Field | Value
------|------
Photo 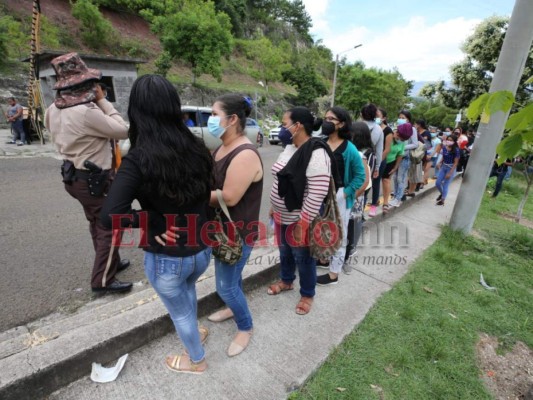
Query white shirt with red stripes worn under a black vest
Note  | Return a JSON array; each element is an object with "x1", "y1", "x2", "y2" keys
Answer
[{"x1": 270, "y1": 145, "x2": 331, "y2": 225}]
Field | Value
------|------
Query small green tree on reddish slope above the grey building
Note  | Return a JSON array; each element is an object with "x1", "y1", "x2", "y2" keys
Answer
[{"x1": 72, "y1": 0, "x2": 117, "y2": 50}]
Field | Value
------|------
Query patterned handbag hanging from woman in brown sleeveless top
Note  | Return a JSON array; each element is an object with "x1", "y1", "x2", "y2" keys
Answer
[{"x1": 212, "y1": 189, "x2": 243, "y2": 265}]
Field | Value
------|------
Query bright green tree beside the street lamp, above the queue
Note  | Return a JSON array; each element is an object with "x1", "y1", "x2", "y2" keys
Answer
[{"x1": 335, "y1": 62, "x2": 412, "y2": 114}]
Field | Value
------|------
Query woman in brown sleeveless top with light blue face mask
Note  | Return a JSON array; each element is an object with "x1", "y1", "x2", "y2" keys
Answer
[{"x1": 207, "y1": 94, "x2": 263, "y2": 357}]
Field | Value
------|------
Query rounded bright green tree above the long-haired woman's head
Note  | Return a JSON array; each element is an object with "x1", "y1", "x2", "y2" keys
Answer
[{"x1": 152, "y1": 1, "x2": 233, "y2": 82}]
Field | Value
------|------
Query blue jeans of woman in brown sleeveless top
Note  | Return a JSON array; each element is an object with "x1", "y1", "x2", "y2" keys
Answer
[{"x1": 215, "y1": 244, "x2": 253, "y2": 331}]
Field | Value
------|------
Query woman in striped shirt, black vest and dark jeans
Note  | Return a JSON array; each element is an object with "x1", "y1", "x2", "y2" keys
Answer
[{"x1": 267, "y1": 107, "x2": 339, "y2": 315}]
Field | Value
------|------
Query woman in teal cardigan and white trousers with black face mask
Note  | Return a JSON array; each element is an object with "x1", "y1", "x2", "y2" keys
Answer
[{"x1": 316, "y1": 107, "x2": 366, "y2": 286}]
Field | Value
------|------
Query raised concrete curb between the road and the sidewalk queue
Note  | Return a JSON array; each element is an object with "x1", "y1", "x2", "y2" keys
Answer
[{"x1": 0, "y1": 179, "x2": 446, "y2": 400}]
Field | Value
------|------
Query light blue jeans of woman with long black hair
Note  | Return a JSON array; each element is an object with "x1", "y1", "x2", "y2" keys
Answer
[{"x1": 144, "y1": 248, "x2": 211, "y2": 362}]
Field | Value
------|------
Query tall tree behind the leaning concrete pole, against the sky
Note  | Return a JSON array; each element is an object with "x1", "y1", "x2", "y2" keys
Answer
[{"x1": 439, "y1": 16, "x2": 533, "y2": 108}]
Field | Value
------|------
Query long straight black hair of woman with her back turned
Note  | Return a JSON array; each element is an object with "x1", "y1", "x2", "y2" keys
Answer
[{"x1": 128, "y1": 75, "x2": 214, "y2": 205}]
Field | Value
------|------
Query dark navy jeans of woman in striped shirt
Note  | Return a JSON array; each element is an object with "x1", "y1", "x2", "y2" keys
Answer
[{"x1": 279, "y1": 225, "x2": 316, "y2": 297}]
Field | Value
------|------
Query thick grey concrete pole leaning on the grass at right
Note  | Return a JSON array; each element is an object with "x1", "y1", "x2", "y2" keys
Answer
[{"x1": 450, "y1": 0, "x2": 533, "y2": 234}]
